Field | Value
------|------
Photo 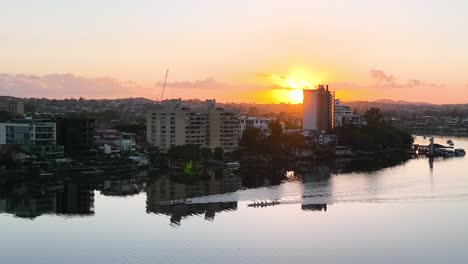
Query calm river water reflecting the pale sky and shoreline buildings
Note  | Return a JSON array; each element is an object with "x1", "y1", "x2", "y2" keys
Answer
[{"x1": 0, "y1": 138, "x2": 468, "y2": 263}]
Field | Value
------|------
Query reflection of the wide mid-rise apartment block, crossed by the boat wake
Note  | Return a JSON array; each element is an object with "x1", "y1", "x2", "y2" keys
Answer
[{"x1": 146, "y1": 170, "x2": 242, "y2": 226}]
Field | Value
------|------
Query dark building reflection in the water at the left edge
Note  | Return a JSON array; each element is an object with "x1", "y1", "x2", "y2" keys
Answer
[{"x1": 0, "y1": 180, "x2": 94, "y2": 218}]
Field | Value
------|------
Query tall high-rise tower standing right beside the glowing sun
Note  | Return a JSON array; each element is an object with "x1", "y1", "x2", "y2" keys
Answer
[{"x1": 303, "y1": 85, "x2": 335, "y2": 132}]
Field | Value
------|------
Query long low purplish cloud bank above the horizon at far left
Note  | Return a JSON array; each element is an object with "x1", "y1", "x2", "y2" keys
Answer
[{"x1": 0, "y1": 73, "x2": 148, "y2": 98}]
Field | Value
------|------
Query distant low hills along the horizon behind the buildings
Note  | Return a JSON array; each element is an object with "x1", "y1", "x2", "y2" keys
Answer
[{"x1": 6, "y1": 97, "x2": 468, "y2": 117}]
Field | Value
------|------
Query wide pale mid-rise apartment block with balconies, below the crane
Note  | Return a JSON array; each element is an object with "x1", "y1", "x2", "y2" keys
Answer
[{"x1": 146, "y1": 99, "x2": 239, "y2": 152}]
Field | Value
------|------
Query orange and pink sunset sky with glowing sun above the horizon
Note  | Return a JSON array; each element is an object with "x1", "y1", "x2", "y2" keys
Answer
[{"x1": 0, "y1": 0, "x2": 468, "y2": 103}]
